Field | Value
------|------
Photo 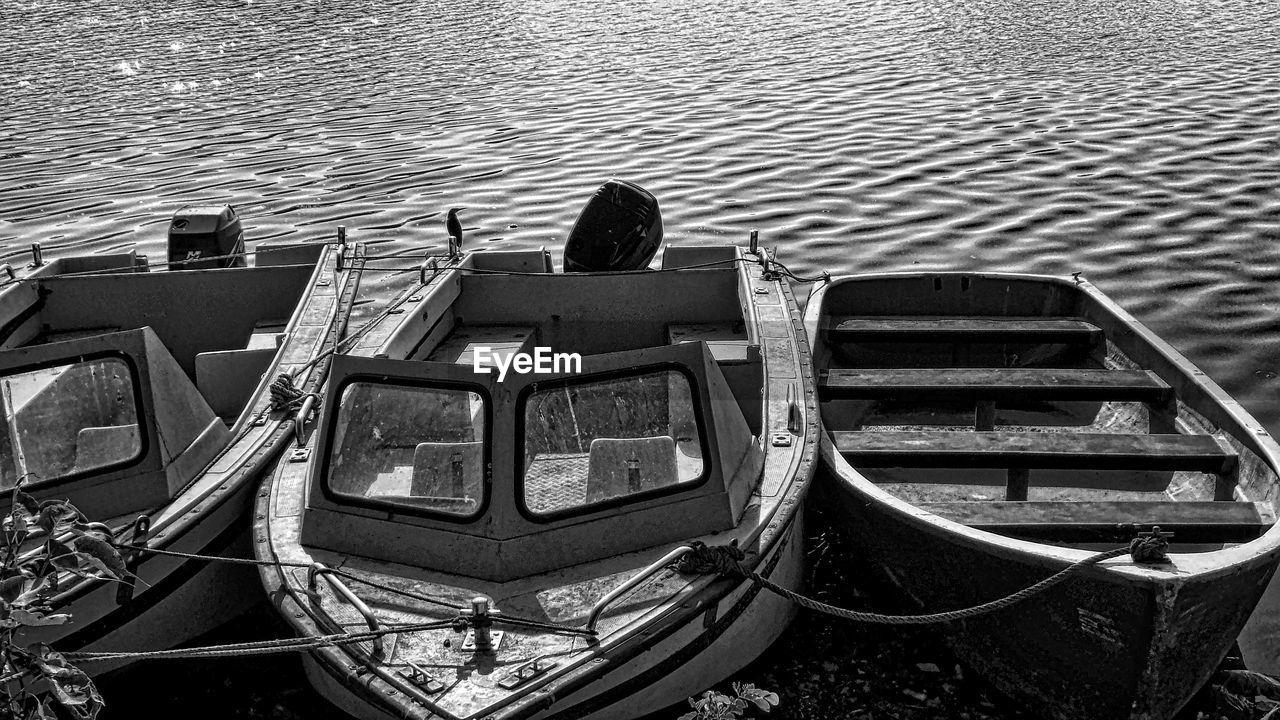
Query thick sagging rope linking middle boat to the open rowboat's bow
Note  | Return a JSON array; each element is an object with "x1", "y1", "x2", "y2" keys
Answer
[{"x1": 676, "y1": 533, "x2": 1169, "y2": 625}]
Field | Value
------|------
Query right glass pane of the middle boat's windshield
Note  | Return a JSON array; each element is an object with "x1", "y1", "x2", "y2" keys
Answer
[{"x1": 524, "y1": 370, "x2": 705, "y2": 514}]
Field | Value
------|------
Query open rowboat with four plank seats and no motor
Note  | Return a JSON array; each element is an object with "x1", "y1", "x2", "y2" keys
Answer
[{"x1": 805, "y1": 273, "x2": 1280, "y2": 720}]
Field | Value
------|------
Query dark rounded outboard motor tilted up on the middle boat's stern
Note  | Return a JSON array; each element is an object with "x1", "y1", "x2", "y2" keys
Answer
[{"x1": 564, "y1": 179, "x2": 662, "y2": 273}]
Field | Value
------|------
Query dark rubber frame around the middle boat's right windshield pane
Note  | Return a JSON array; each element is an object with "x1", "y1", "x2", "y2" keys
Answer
[{"x1": 512, "y1": 360, "x2": 716, "y2": 525}]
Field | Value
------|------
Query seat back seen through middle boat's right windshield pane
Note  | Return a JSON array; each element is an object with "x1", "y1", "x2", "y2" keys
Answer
[{"x1": 586, "y1": 436, "x2": 680, "y2": 502}]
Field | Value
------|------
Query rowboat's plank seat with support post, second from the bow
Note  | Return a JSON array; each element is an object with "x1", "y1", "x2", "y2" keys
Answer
[{"x1": 831, "y1": 430, "x2": 1239, "y2": 500}]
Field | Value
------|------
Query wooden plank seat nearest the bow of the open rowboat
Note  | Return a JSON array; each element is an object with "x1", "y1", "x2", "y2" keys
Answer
[{"x1": 916, "y1": 501, "x2": 1276, "y2": 543}]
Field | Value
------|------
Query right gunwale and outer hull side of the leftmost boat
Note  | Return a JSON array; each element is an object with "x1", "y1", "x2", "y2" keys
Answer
[{"x1": 8, "y1": 243, "x2": 356, "y2": 675}]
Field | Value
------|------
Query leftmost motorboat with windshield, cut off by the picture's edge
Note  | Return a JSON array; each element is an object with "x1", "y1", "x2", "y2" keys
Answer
[{"x1": 0, "y1": 209, "x2": 358, "y2": 674}]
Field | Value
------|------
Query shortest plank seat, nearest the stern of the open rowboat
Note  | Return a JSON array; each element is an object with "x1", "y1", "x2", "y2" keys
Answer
[{"x1": 827, "y1": 316, "x2": 1102, "y2": 345}]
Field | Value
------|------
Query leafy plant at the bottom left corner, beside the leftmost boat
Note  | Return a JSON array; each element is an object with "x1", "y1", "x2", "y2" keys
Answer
[{"x1": 0, "y1": 487, "x2": 128, "y2": 720}]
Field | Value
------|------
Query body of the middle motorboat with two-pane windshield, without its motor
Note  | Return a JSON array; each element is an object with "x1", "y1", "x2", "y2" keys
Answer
[{"x1": 255, "y1": 242, "x2": 818, "y2": 720}]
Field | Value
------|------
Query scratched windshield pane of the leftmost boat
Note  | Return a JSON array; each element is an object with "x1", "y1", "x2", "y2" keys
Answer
[{"x1": 0, "y1": 357, "x2": 142, "y2": 489}]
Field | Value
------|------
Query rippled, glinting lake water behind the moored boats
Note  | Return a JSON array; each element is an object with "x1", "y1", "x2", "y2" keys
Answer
[{"x1": 0, "y1": 0, "x2": 1280, "y2": 712}]
